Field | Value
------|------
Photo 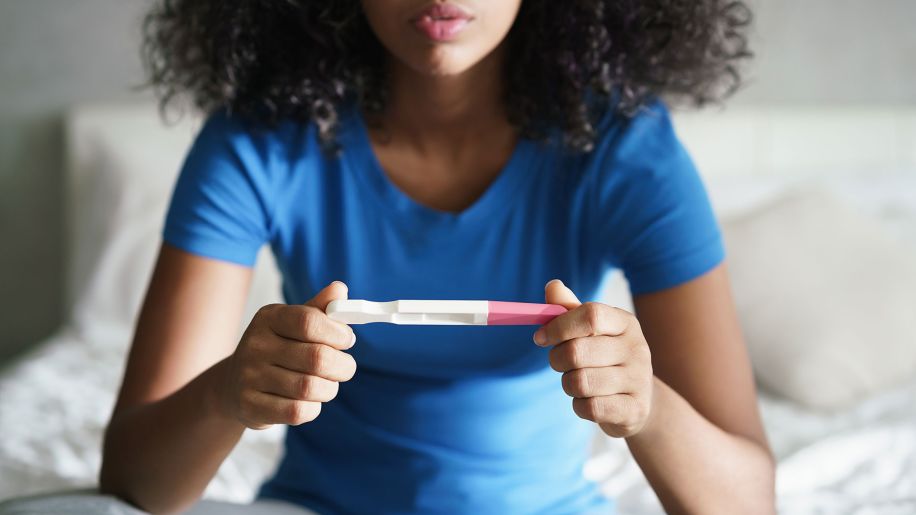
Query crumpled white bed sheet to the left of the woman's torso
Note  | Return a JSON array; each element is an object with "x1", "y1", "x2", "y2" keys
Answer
[{"x1": 0, "y1": 330, "x2": 283, "y2": 501}]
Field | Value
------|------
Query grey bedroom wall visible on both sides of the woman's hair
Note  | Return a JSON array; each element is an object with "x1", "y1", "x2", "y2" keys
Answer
[{"x1": 0, "y1": 0, "x2": 916, "y2": 362}]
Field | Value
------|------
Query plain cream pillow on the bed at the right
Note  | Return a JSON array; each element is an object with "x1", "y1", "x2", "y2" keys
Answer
[{"x1": 722, "y1": 188, "x2": 916, "y2": 409}]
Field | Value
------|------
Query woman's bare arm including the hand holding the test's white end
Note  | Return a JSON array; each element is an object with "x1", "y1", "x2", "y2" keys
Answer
[{"x1": 100, "y1": 244, "x2": 356, "y2": 513}]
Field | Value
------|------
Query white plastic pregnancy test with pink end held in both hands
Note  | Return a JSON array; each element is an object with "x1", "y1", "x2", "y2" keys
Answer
[{"x1": 325, "y1": 299, "x2": 566, "y2": 325}]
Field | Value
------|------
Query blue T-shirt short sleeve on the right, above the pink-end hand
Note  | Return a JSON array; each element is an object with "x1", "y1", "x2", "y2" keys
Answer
[{"x1": 590, "y1": 102, "x2": 725, "y2": 295}]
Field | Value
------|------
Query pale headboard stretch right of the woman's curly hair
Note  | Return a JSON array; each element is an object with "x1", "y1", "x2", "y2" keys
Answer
[{"x1": 675, "y1": 106, "x2": 916, "y2": 177}]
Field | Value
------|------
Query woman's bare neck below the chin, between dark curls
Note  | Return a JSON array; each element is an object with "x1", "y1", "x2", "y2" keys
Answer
[{"x1": 380, "y1": 46, "x2": 511, "y2": 153}]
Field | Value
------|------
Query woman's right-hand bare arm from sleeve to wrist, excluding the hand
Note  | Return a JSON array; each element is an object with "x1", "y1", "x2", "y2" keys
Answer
[{"x1": 627, "y1": 265, "x2": 775, "y2": 513}]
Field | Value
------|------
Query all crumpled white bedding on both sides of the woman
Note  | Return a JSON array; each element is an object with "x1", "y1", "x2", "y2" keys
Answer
[{"x1": 0, "y1": 330, "x2": 916, "y2": 514}]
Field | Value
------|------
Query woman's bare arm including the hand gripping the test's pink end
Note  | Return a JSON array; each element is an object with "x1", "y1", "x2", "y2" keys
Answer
[{"x1": 536, "y1": 265, "x2": 775, "y2": 514}]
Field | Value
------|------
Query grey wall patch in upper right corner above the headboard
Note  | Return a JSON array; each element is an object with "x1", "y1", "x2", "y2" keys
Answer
[{"x1": 735, "y1": 0, "x2": 916, "y2": 104}]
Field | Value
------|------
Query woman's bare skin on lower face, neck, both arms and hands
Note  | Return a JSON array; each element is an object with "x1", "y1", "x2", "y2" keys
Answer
[{"x1": 100, "y1": 0, "x2": 774, "y2": 513}]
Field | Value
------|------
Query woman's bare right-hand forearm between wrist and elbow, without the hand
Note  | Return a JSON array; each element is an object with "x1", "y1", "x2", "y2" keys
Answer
[{"x1": 627, "y1": 377, "x2": 775, "y2": 514}]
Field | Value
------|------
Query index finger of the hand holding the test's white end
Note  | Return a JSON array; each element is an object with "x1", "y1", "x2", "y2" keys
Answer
[{"x1": 270, "y1": 305, "x2": 356, "y2": 349}]
